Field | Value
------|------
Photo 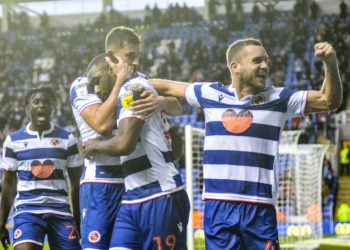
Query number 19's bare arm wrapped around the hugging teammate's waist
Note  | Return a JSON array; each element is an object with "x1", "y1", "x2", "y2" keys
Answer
[{"x1": 83, "y1": 117, "x2": 144, "y2": 156}]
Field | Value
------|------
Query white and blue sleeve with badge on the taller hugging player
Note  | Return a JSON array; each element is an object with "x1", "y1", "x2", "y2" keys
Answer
[{"x1": 70, "y1": 77, "x2": 102, "y2": 113}]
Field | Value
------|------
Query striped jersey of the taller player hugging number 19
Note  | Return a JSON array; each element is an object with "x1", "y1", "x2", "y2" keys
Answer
[{"x1": 70, "y1": 77, "x2": 124, "y2": 184}]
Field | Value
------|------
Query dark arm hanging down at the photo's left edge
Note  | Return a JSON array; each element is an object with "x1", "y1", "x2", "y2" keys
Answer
[{"x1": 0, "y1": 170, "x2": 17, "y2": 249}]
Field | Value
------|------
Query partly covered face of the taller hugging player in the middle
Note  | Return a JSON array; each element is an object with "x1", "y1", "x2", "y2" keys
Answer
[{"x1": 112, "y1": 42, "x2": 141, "y2": 71}]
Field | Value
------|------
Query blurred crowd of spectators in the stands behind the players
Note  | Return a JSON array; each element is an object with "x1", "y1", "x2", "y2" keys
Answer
[{"x1": 0, "y1": 0, "x2": 350, "y2": 148}]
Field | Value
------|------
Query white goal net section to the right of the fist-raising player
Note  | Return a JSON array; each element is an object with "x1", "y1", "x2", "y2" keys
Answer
[{"x1": 275, "y1": 144, "x2": 327, "y2": 249}]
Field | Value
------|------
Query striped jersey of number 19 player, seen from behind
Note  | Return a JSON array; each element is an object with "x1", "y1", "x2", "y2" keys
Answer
[{"x1": 118, "y1": 77, "x2": 183, "y2": 204}]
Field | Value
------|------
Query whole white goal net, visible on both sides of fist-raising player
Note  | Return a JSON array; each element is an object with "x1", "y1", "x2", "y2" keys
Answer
[{"x1": 185, "y1": 126, "x2": 327, "y2": 250}]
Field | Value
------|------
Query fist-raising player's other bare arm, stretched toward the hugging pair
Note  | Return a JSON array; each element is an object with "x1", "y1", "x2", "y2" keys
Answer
[{"x1": 149, "y1": 79, "x2": 190, "y2": 97}]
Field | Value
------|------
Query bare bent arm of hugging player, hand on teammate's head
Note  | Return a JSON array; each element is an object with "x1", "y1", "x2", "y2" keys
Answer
[{"x1": 81, "y1": 57, "x2": 133, "y2": 135}]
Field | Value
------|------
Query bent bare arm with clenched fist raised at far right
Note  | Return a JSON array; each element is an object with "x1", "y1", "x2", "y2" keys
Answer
[{"x1": 305, "y1": 42, "x2": 343, "y2": 113}]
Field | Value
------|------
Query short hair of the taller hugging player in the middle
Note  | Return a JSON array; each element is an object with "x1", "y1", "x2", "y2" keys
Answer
[{"x1": 105, "y1": 26, "x2": 141, "y2": 52}]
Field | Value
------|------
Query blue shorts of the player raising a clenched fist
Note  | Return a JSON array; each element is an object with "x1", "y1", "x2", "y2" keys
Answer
[{"x1": 203, "y1": 200, "x2": 280, "y2": 250}]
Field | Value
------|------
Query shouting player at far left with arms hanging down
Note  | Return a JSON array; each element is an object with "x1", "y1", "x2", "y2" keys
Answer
[{"x1": 0, "y1": 87, "x2": 83, "y2": 250}]
